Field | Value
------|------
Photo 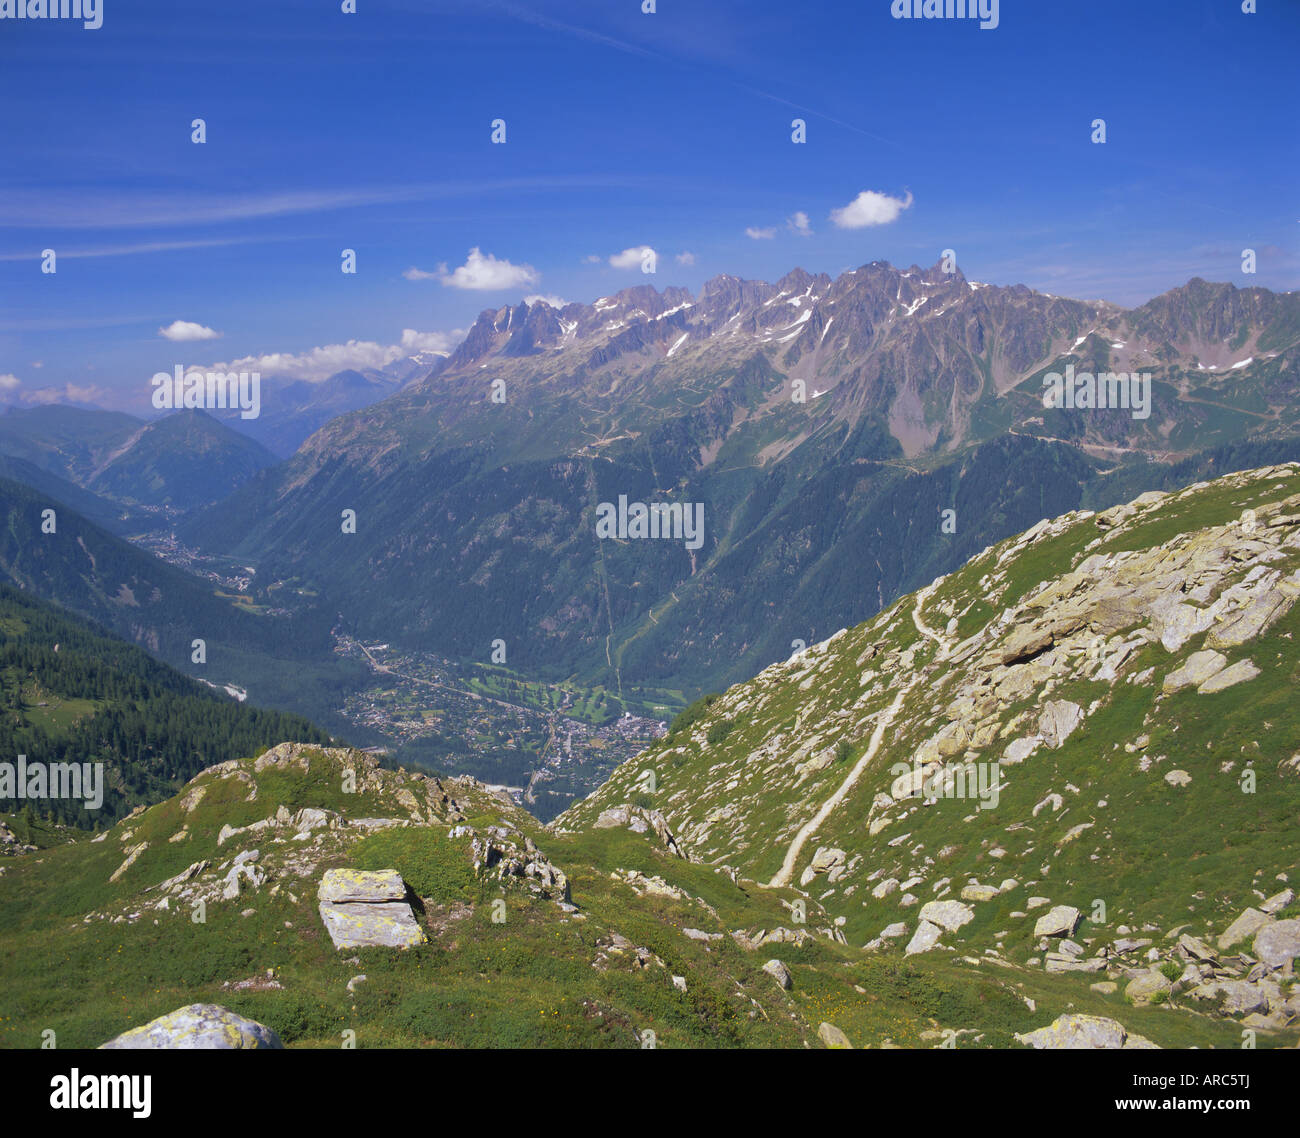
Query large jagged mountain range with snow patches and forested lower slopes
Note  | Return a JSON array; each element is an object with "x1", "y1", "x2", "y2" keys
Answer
[{"x1": 183, "y1": 263, "x2": 1300, "y2": 688}]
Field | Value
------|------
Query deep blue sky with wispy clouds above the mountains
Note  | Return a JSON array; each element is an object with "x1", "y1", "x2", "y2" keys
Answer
[{"x1": 0, "y1": 0, "x2": 1300, "y2": 412}]
